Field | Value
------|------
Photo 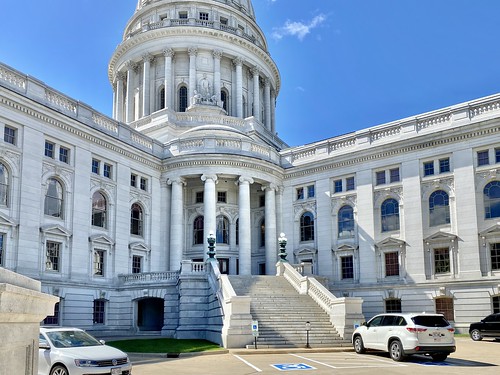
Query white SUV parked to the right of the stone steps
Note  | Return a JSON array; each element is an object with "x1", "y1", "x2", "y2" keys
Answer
[{"x1": 352, "y1": 313, "x2": 456, "y2": 361}]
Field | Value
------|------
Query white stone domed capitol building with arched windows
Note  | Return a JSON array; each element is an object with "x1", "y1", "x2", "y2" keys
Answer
[{"x1": 0, "y1": 0, "x2": 500, "y2": 347}]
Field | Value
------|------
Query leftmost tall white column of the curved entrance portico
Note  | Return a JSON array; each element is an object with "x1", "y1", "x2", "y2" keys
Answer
[{"x1": 168, "y1": 177, "x2": 186, "y2": 271}]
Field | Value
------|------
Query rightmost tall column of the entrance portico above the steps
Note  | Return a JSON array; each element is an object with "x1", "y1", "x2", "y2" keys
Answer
[{"x1": 262, "y1": 184, "x2": 278, "y2": 275}]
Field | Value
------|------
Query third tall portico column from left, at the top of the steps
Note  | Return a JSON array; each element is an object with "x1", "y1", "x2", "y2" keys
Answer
[{"x1": 238, "y1": 176, "x2": 253, "y2": 275}]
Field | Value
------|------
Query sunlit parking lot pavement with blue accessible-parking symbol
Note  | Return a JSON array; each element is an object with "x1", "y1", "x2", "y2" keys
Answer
[{"x1": 130, "y1": 337, "x2": 500, "y2": 375}]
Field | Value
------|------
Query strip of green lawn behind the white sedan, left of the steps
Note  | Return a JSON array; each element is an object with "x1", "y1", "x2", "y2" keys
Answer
[{"x1": 106, "y1": 338, "x2": 223, "y2": 353}]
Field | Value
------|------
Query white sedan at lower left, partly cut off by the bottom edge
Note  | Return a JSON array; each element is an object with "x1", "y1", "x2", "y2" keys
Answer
[{"x1": 38, "y1": 327, "x2": 132, "y2": 375}]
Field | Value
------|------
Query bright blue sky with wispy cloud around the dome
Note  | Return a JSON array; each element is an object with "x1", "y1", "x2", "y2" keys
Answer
[{"x1": 0, "y1": 0, "x2": 500, "y2": 146}]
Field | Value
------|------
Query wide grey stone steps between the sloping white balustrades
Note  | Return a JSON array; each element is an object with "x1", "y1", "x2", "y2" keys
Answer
[{"x1": 229, "y1": 276, "x2": 351, "y2": 348}]
